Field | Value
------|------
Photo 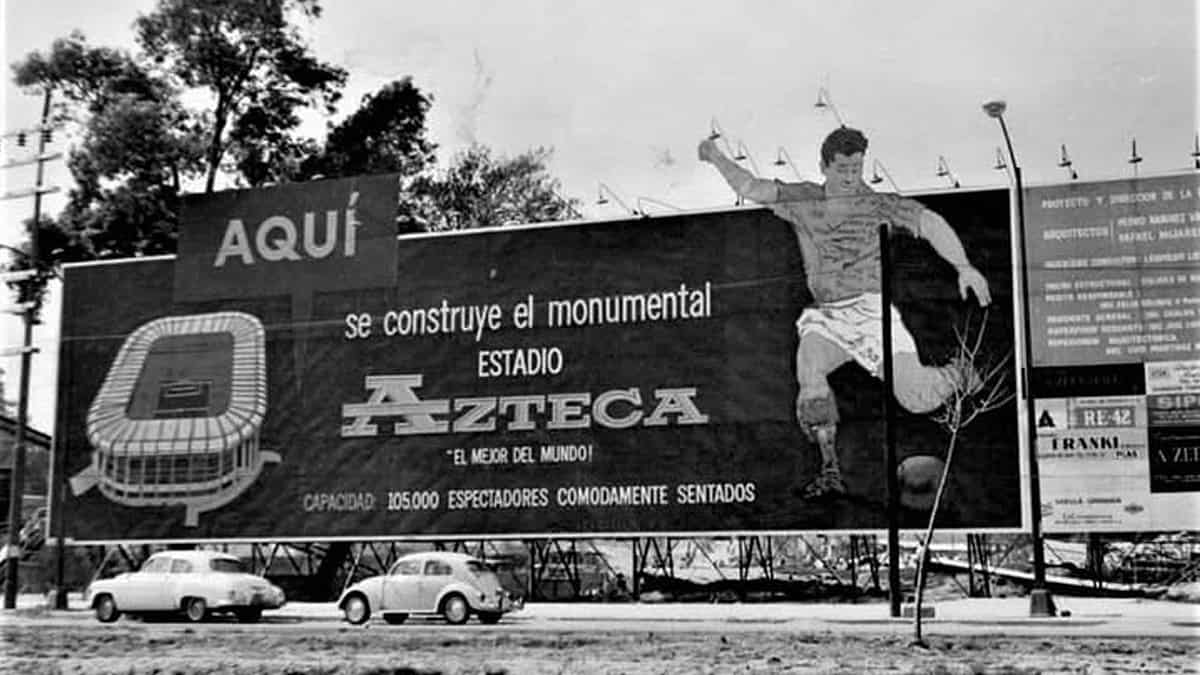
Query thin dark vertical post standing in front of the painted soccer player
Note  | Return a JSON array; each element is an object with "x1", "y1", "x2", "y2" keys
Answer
[{"x1": 880, "y1": 223, "x2": 900, "y2": 619}]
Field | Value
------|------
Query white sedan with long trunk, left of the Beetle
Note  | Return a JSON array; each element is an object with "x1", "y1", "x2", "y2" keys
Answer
[{"x1": 88, "y1": 550, "x2": 286, "y2": 623}]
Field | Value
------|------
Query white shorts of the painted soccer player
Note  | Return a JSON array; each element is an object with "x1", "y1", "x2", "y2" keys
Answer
[{"x1": 796, "y1": 293, "x2": 917, "y2": 378}]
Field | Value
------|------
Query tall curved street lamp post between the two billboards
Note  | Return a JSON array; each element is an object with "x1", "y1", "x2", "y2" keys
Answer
[{"x1": 983, "y1": 101, "x2": 1057, "y2": 616}]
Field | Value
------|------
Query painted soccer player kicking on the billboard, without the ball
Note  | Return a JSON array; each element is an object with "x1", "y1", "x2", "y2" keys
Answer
[{"x1": 700, "y1": 126, "x2": 991, "y2": 498}]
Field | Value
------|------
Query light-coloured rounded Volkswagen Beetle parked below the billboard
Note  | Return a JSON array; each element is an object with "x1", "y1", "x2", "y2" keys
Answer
[{"x1": 337, "y1": 551, "x2": 520, "y2": 623}]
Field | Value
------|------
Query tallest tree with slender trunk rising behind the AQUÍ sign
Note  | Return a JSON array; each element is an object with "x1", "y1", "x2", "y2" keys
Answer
[{"x1": 134, "y1": 0, "x2": 346, "y2": 192}]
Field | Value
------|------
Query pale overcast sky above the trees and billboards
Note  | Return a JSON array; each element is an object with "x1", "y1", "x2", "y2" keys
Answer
[{"x1": 0, "y1": 0, "x2": 1200, "y2": 431}]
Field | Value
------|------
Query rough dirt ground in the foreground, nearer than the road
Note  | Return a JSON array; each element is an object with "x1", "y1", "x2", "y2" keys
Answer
[{"x1": 0, "y1": 621, "x2": 1200, "y2": 675}]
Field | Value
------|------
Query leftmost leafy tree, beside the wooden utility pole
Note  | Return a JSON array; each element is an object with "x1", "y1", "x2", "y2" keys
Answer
[{"x1": 10, "y1": 31, "x2": 200, "y2": 300}]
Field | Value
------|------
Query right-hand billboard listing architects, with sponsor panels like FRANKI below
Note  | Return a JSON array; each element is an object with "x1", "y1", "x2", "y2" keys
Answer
[{"x1": 1026, "y1": 174, "x2": 1200, "y2": 532}]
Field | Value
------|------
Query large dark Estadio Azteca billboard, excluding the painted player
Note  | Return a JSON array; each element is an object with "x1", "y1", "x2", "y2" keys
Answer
[{"x1": 51, "y1": 180, "x2": 1021, "y2": 542}]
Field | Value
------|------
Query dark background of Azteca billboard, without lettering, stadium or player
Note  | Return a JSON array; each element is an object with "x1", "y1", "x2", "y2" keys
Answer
[{"x1": 56, "y1": 190, "x2": 1021, "y2": 540}]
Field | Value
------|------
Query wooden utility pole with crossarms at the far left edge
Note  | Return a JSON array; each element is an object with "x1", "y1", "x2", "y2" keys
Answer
[{"x1": 4, "y1": 89, "x2": 50, "y2": 609}]
